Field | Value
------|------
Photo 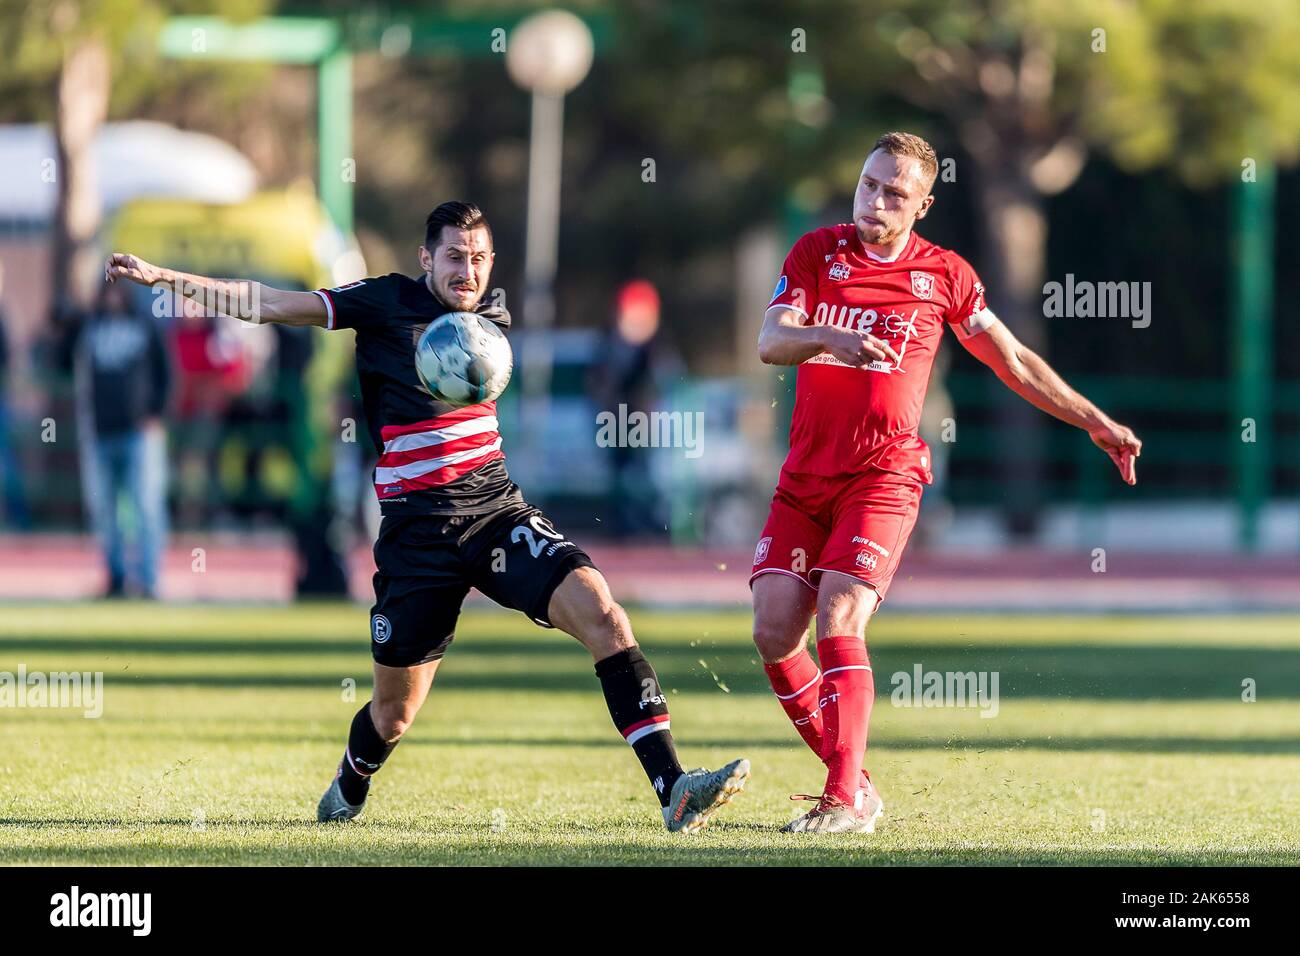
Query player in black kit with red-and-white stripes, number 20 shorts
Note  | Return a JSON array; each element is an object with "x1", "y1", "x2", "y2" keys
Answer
[{"x1": 104, "y1": 202, "x2": 749, "y2": 832}]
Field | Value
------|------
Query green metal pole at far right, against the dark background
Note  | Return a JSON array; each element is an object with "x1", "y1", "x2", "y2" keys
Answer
[{"x1": 1231, "y1": 160, "x2": 1275, "y2": 551}]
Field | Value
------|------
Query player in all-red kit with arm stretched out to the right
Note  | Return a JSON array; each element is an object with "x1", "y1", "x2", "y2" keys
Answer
[{"x1": 750, "y1": 133, "x2": 1141, "y2": 832}]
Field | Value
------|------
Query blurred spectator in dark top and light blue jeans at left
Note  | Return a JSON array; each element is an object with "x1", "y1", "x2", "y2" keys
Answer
[{"x1": 75, "y1": 284, "x2": 172, "y2": 598}]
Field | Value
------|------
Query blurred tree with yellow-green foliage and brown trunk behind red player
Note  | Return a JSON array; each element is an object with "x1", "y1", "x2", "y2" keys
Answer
[{"x1": 865, "y1": 0, "x2": 1300, "y2": 532}]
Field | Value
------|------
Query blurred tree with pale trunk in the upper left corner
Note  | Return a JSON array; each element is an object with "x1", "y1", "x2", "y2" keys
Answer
[{"x1": 0, "y1": 0, "x2": 267, "y2": 317}]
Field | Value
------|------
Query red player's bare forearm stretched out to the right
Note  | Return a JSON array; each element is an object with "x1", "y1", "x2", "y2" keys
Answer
[{"x1": 961, "y1": 319, "x2": 1141, "y2": 485}]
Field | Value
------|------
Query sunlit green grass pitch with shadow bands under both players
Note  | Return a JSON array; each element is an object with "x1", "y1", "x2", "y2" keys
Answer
[{"x1": 0, "y1": 604, "x2": 1300, "y2": 865}]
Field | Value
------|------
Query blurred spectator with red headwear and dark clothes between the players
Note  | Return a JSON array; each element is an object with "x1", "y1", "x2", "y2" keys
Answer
[{"x1": 592, "y1": 280, "x2": 681, "y2": 537}]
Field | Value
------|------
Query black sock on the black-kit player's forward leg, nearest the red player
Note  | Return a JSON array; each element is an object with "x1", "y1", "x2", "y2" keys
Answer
[{"x1": 595, "y1": 648, "x2": 681, "y2": 806}]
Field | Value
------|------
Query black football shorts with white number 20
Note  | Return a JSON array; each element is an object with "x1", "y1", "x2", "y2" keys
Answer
[{"x1": 371, "y1": 501, "x2": 594, "y2": 667}]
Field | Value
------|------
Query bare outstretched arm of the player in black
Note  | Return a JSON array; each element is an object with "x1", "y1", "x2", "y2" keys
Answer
[{"x1": 104, "y1": 252, "x2": 326, "y2": 326}]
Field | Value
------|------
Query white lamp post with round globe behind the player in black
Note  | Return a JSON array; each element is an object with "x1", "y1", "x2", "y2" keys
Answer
[{"x1": 506, "y1": 10, "x2": 594, "y2": 451}]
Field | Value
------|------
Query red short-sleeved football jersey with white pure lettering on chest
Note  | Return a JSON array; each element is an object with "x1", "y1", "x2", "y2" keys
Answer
[{"x1": 771, "y1": 222, "x2": 992, "y2": 484}]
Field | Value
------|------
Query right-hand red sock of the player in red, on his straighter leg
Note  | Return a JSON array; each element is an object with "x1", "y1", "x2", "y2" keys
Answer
[{"x1": 816, "y1": 637, "x2": 876, "y2": 804}]
